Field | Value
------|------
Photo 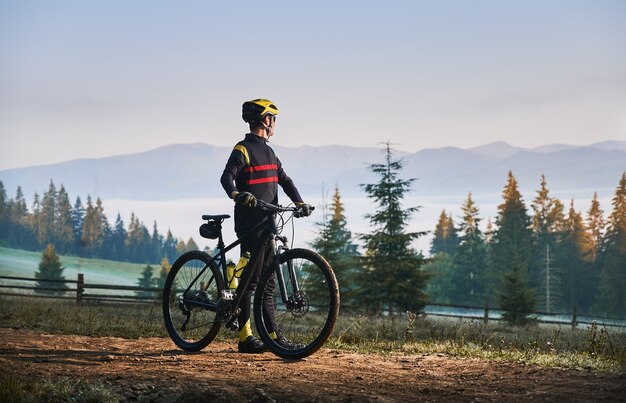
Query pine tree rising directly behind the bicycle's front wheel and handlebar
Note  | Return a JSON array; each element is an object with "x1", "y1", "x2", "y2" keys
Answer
[{"x1": 311, "y1": 187, "x2": 359, "y2": 306}]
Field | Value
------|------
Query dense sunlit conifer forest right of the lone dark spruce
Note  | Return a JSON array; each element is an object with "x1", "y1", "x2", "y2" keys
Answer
[{"x1": 426, "y1": 172, "x2": 626, "y2": 321}]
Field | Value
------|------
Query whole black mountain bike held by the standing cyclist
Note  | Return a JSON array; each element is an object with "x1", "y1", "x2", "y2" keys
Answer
[{"x1": 163, "y1": 200, "x2": 339, "y2": 359}]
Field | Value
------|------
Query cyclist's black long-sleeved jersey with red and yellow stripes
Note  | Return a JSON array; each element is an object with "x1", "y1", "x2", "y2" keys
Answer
[{"x1": 220, "y1": 133, "x2": 302, "y2": 233}]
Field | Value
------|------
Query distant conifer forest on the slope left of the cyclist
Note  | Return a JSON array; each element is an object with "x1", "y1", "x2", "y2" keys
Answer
[{"x1": 0, "y1": 181, "x2": 198, "y2": 264}]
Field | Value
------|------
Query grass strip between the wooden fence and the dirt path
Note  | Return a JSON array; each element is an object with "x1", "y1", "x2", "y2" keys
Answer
[{"x1": 0, "y1": 297, "x2": 626, "y2": 373}]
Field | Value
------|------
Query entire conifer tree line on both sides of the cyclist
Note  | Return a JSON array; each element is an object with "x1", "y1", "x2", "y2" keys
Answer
[{"x1": 0, "y1": 147, "x2": 626, "y2": 323}]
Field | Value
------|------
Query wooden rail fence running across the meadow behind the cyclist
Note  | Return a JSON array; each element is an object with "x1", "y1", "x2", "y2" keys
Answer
[{"x1": 0, "y1": 273, "x2": 626, "y2": 328}]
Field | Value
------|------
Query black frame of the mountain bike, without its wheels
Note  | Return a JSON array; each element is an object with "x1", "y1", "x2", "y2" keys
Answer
[{"x1": 183, "y1": 213, "x2": 299, "y2": 320}]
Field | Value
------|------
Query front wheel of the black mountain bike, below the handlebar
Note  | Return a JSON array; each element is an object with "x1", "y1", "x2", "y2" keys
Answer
[{"x1": 254, "y1": 249, "x2": 339, "y2": 359}]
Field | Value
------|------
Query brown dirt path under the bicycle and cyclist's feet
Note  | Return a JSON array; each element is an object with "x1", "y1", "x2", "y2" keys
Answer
[{"x1": 0, "y1": 329, "x2": 626, "y2": 402}]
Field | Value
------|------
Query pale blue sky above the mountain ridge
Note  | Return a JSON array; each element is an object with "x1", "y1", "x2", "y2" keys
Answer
[{"x1": 0, "y1": 0, "x2": 626, "y2": 169}]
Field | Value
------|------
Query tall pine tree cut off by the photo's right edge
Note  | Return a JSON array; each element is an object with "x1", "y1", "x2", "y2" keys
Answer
[{"x1": 596, "y1": 173, "x2": 626, "y2": 316}]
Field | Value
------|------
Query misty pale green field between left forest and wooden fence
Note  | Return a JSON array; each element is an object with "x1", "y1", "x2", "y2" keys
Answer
[{"x1": 0, "y1": 247, "x2": 159, "y2": 285}]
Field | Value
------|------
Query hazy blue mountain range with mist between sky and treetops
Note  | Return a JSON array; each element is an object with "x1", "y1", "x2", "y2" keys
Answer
[{"x1": 0, "y1": 141, "x2": 626, "y2": 200}]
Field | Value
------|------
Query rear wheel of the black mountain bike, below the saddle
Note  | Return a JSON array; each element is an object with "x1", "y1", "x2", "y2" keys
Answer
[{"x1": 163, "y1": 251, "x2": 224, "y2": 351}]
